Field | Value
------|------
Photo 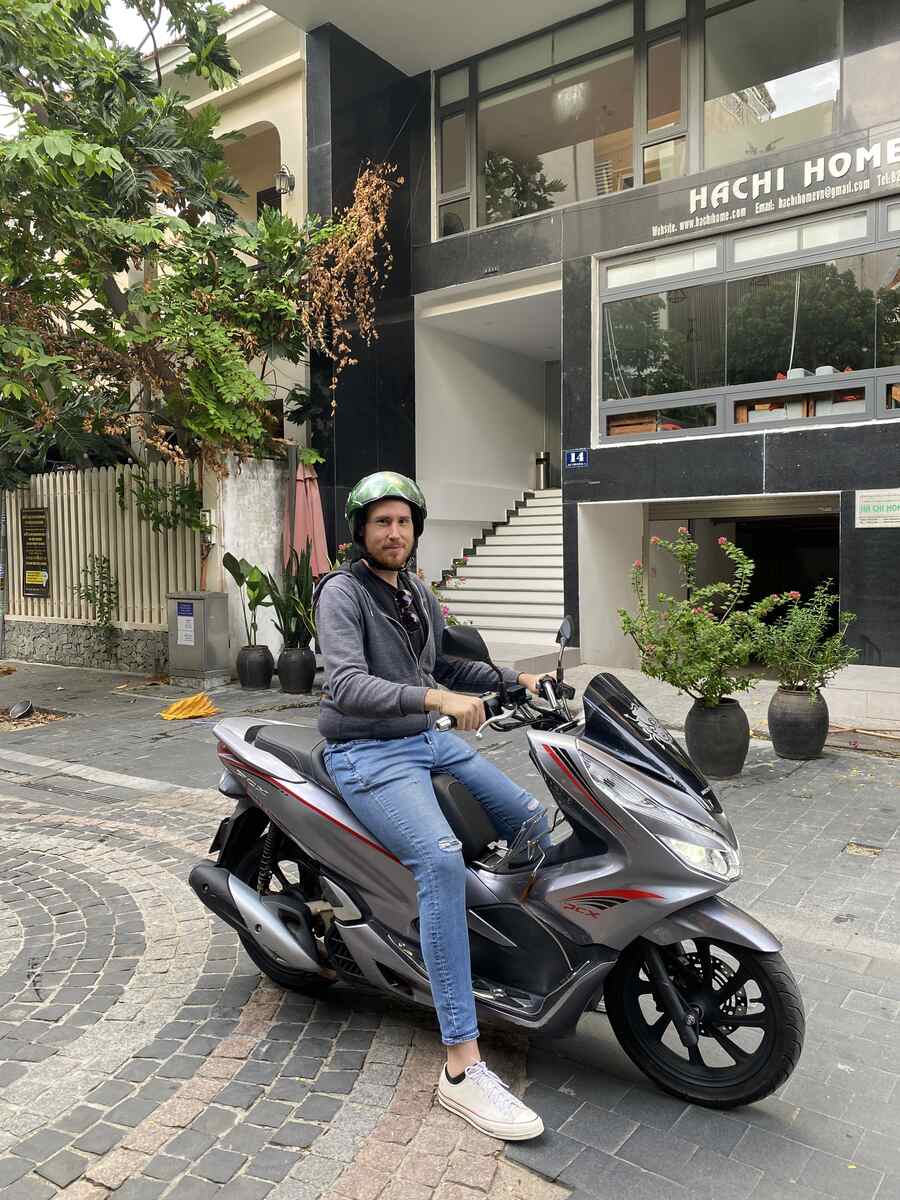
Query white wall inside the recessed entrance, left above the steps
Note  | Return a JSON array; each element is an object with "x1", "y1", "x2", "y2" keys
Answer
[{"x1": 415, "y1": 317, "x2": 545, "y2": 580}]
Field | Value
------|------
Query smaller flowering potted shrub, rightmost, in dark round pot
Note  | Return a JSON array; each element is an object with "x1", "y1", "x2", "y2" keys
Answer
[{"x1": 755, "y1": 580, "x2": 857, "y2": 760}]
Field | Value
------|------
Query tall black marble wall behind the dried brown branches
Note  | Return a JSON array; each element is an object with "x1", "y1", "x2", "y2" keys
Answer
[{"x1": 307, "y1": 25, "x2": 430, "y2": 551}]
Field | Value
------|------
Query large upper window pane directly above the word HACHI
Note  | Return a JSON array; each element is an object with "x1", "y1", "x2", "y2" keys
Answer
[{"x1": 703, "y1": 0, "x2": 844, "y2": 167}]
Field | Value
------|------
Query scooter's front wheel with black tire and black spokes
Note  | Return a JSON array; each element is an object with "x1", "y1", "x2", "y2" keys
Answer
[{"x1": 605, "y1": 938, "x2": 806, "y2": 1109}]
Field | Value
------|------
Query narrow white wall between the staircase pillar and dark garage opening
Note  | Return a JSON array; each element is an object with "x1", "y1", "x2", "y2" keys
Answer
[{"x1": 578, "y1": 503, "x2": 646, "y2": 667}]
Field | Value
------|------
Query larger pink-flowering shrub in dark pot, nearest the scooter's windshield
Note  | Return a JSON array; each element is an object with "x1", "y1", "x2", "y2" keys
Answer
[{"x1": 619, "y1": 527, "x2": 779, "y2": 779}]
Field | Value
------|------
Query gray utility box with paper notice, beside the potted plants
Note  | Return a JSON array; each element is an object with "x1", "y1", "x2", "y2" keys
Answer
[{"x1": 166, "y1": 592, "x2": 232, "y2": 688}]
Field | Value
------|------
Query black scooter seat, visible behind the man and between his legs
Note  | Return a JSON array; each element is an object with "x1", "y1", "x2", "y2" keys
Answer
[{"x1": 253, "y1": 725, "x2": 498, "y2": 863}]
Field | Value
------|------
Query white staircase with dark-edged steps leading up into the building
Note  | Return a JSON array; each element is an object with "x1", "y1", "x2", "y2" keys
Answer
[{"x1": 440, "y1": 488, "x2": 563, "y2": 671}]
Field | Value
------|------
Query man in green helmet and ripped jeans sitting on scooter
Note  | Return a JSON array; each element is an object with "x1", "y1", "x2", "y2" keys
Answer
[{"x1": 314, "y1": 472, "x2": 554, "y2": 1140}]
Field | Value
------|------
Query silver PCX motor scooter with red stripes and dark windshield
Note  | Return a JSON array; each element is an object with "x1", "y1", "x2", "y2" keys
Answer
[{"x1": 190, "y1": 618, "x2": 804, "y2": 1109}]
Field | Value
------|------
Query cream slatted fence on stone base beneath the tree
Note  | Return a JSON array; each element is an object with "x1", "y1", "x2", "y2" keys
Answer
[{"x1": 6, "y1": 463, "x2": 200, "y2": 629}]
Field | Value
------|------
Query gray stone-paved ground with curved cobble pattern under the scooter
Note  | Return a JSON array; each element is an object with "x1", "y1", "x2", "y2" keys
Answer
[{"x1": 0, "y1": 662, "x2": 900, "y2": 1200}]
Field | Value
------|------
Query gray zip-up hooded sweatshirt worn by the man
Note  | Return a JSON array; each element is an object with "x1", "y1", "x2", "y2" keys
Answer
[{"x1": 313, "y1": 564, "x2": 516, "y2": 742}]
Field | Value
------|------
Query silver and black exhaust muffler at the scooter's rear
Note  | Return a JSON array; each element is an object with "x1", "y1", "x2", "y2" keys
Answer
[{"x1": 187, "y1": 863, "x2": 323, "y2": 974}]
